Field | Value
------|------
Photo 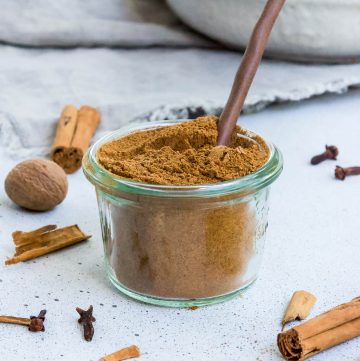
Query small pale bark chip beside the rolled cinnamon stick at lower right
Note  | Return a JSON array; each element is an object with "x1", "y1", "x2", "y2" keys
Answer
[{"x1": 282, "y1": 291, "x2": 316, "y2": 327}]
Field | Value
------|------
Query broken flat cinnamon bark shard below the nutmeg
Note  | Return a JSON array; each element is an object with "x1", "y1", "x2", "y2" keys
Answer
[{"x1": 5, "y1": 225, "x2": 91, "y2": 265}]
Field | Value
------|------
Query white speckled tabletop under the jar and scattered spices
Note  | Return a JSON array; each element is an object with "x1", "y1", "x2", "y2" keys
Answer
[{"x1": 0, "y1": 90, "x2": 360, "y2": 361}]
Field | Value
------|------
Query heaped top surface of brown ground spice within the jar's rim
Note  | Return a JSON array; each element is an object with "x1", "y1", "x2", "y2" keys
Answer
[{"x1": 97, "y1": 116, "x2": 269, "y2": 185}]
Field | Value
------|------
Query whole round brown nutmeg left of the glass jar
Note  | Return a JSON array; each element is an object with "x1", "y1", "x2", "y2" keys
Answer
[{"x1": 5, "y1": 159, "x2": 68, "y2": 211}]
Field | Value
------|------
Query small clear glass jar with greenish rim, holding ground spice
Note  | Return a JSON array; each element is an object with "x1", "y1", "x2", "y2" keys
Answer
[{"x1": 83, "y1": 122, "x2": 283, "y2": 307}]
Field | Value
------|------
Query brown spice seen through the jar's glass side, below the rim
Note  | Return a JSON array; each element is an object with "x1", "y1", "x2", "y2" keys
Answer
[{"x1": 107, "y1": 196, "x2": 260, "y2": 299}]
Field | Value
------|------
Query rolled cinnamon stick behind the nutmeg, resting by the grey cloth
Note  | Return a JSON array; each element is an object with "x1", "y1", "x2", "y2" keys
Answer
[{"x1": 50, "y1": 105, "x2": 100, "y2": 173}]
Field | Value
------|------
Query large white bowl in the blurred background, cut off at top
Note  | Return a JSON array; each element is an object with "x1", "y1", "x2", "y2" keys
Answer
[{"x1": 167, "y1": 0, "x2": 360, "y2": 62}]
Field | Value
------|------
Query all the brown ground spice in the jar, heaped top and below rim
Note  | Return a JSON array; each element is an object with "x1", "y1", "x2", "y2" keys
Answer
[{"x1": 97, "y1": 117, "x2": 269, "y2": 299}]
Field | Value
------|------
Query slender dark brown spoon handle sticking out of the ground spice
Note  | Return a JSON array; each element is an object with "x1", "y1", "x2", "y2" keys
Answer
[{"x1": 218, "y1": 0, "x2": 285, "y2": 145}]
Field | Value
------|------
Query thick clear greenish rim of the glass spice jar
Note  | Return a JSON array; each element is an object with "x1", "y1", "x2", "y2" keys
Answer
[{"x1": 82, "y1": 120, "x2": 283, "y2": 197}]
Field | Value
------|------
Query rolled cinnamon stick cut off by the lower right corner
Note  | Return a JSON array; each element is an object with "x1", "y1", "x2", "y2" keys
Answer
[{"x1": 277, "y1": 297, "x2": 360, "y2": 361}]
